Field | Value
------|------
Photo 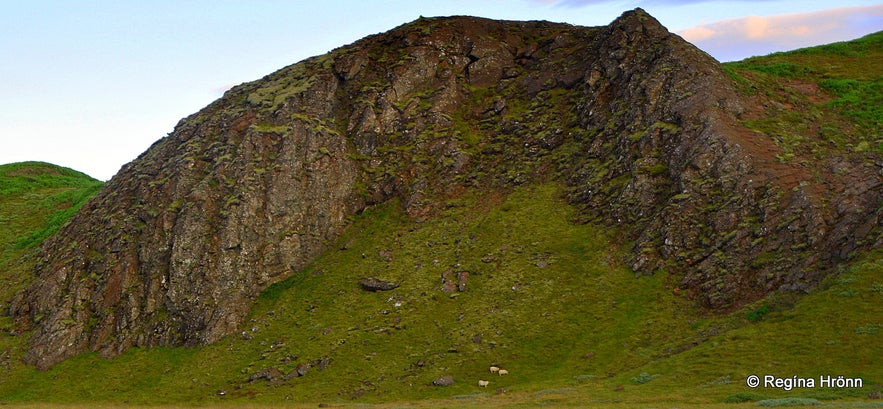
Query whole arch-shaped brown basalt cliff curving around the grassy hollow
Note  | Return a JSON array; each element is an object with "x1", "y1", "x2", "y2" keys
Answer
[{"x1": 12, "y1": 9, "x2": 880, "y2": 368}]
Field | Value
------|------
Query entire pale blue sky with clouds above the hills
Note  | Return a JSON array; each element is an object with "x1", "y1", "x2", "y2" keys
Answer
[{"x1": 0, "y1": 0, "x2": 883, "y2": 180}]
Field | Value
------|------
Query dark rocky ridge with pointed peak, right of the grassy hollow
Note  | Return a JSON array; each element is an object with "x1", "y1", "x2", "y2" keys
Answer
[{"x1": 565, "y1": 11, "x2": 883, "y2": 310}]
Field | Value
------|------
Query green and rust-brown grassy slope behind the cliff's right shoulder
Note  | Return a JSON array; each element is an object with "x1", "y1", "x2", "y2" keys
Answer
[{"x1": 724, "y1": 32, "x2": 883, "y2": 156}]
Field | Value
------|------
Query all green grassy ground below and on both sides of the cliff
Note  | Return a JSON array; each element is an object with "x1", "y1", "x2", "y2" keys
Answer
[{"x1": 0, "y1": 33, "x2": 883, "y2": 408}]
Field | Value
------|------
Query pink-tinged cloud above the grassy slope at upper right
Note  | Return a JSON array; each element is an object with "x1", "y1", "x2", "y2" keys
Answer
[{"x1": 678, "y1": 4, "x2": 883, "y2": 61}]
